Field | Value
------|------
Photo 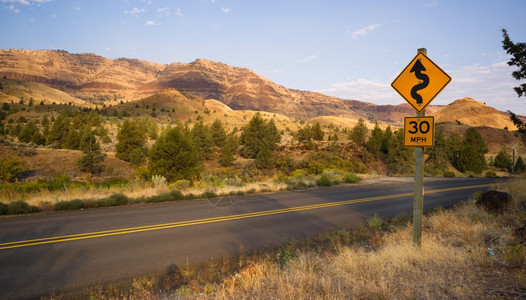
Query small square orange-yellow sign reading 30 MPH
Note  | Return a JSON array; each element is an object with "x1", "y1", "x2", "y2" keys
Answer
[{"x1": 404, "y1": 117, "x2": 435, "y2": 147}]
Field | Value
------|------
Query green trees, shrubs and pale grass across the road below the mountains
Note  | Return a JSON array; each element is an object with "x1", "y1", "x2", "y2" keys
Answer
[{"x1": 0, "y1": 96, "x2": 526, "y2": 214}]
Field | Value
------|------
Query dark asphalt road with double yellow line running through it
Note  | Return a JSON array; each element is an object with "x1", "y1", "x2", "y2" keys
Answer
[{"x1": 0, "y1": 178, "x2": 504, "y2": 299}]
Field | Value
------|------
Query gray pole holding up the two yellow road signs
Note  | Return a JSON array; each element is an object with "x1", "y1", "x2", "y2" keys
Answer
[{"x1": 413, "y1": 48, "x2": 427, "y2": 247}]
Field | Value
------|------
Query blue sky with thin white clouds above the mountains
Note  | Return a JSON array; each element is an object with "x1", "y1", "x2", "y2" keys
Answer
[{"x1": 0, "y1": 0, "x2": 526, "y2": 115}]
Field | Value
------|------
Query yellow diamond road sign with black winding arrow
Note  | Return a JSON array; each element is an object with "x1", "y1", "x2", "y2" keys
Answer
[{"x1": 391, "y1": 52, "x2": 451, "y2": 112}]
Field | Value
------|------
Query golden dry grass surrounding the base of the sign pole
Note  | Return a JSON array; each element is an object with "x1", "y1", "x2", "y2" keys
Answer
[{"x1": 201, "y1": 179, "x2": 526, "y2": 299}]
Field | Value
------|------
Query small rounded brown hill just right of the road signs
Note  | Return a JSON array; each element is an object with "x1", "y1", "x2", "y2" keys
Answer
[{"x1": 432, "y1": 98, "x2": 517, "y2": 130}]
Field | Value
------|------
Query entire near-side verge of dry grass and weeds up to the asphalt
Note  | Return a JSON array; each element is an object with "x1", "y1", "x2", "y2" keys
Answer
[{"x1": 50, "y1": 177, "x2": 526, "y2": 299}]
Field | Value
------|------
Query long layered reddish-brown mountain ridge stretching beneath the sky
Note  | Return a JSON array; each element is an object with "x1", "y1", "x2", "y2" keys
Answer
[{"x1": 0, "y1": 50, "x2": 512, "y2": 128}]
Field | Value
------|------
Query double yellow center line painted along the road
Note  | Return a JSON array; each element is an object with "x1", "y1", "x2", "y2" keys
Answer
[{"x1": 0, "y1": 184, "x2": 490, "y2": 250}]
